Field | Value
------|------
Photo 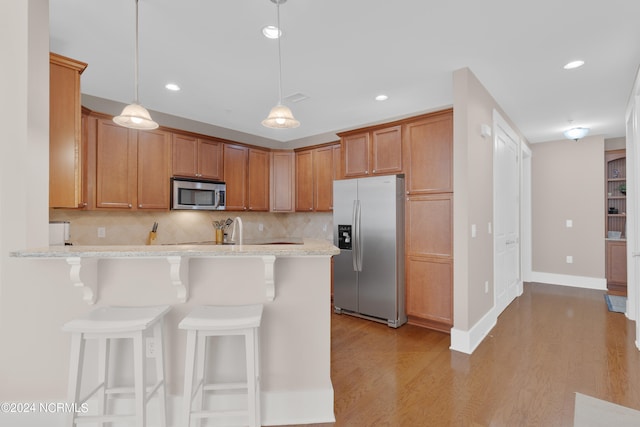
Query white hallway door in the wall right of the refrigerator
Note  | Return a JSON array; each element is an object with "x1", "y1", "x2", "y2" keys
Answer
[{"x1": 493, "y1": 111, "x2": 521, "y2": 315}]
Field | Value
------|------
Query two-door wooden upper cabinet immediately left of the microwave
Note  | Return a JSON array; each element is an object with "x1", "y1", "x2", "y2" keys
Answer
[{"x1": 89, "y1": 118, "x2": 171, "y2": 210}]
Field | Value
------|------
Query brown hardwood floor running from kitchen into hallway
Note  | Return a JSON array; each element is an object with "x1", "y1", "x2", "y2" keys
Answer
[{"x1": 282, "y1": 283, "x2": 640, "y2": 427}]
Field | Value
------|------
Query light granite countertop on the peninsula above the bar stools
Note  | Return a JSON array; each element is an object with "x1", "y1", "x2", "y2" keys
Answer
[{"x1": 10, "y1": 239, "x2": 340, "y2": 258}]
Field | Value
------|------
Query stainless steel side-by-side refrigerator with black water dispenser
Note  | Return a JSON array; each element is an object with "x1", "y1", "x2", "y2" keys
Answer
[{"x1": 333, "y1": 175, "x2": 407, "y2": 328}]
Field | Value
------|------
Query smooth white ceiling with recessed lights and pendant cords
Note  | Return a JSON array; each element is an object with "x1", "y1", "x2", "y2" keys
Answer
[{"x1": 49, "y1": 0, "x2": 640, "y2": 146}]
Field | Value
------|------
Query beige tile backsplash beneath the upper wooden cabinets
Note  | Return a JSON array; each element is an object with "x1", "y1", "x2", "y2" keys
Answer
[{"x1": 49, "y1": 209, "x2": 333, "y2": 245}]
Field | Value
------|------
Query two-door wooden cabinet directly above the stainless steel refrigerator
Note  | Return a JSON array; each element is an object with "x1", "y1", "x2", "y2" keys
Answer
[{"x1": 339, "y1": 125, "x2": 402, "y2": 178}]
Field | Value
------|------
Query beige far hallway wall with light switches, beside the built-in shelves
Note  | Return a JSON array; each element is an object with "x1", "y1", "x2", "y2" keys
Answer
[{"x1": 531, "y1": 136, "x2": 606, "y2": 289}]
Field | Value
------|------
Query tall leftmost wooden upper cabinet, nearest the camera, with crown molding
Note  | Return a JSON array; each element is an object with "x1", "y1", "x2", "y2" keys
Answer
[{"x1": 49, "y1": 53, "x2": 87, "y2": 208}]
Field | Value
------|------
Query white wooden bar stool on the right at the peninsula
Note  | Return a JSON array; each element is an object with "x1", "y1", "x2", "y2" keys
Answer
[{"x1": 179, "y1": 304, "x2": 262, "y2": 427}]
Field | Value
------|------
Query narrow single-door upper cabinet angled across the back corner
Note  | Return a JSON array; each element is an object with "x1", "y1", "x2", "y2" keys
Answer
[{"x1": 270, "y1": 151, "x2": 295, "y2": 212}]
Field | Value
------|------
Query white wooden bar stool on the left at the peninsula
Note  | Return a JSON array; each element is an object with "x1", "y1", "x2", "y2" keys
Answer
[{"x1": 62, "y1": 305, "x2": 170, "y2": 427}]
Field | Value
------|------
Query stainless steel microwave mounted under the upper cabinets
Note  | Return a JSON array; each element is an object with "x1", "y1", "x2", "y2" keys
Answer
[{"x1": 171, "y1": 178, "x2": 227, "y2": 211}]
